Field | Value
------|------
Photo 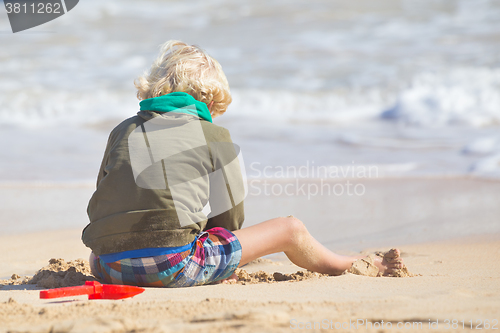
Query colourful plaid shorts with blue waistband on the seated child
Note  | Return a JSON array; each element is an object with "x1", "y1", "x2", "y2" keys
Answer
[{"x1": 94, "y1": 227, "x2": 241, "y2": 288}]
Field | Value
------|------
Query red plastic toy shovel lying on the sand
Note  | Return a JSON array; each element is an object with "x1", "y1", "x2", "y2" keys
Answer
[{"x1": 40, "y1": 281, "x2": 145, "y2": 299}]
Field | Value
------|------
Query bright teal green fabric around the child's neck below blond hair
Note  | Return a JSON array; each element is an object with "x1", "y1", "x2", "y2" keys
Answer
[{"x1": 139, "y1": 92, "x2": 212, "y2": 122}]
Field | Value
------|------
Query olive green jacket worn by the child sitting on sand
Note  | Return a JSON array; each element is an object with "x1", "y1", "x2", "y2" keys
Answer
[{"x1": 82, "y1": 111, "x2": 244, "y2": 255}]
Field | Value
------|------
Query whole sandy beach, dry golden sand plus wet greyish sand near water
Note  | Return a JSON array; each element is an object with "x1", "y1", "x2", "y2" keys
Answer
[{"x1": 0, "y1": 177, "x2": 500, "y2": 332}]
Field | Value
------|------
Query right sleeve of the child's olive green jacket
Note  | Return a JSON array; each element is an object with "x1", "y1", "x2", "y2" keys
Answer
[{"x1": 205, "y1": 129, "x2": 246, "y2": 231}]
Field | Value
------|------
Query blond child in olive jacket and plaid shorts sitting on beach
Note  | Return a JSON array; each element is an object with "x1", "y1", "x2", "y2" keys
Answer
[{"x1": 82, "y1": 41, "x2": 403, "y2": 287}]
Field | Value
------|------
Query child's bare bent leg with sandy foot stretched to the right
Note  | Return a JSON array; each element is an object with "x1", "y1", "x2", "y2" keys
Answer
[{"x1": 233, "y1": 216, "x2": 403, "y2": 275}]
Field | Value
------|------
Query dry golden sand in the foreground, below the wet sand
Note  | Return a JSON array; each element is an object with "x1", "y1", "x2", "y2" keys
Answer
[{"x1": 0, "y1": 230, "x2": 500, "y2": 332}]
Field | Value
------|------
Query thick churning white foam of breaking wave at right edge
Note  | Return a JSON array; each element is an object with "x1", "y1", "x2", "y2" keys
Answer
[{"x1": 382, "y1": 68, "x2": 500, "y2": 127}]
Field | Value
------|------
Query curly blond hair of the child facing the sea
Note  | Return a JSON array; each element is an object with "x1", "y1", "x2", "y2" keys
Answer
[{"x1": 134, "y1": 40, "x2": 232, "y2": 117}]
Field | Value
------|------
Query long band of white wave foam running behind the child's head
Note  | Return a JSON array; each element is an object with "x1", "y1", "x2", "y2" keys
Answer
[{"x1": 0, "y1": 67, "x2": 500, "y2": 128}]
